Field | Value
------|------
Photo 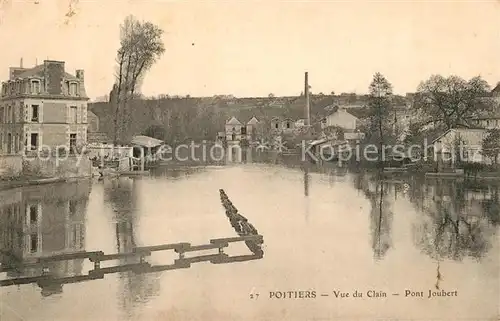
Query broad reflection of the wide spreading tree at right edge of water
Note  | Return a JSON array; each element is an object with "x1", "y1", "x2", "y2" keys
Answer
[{"x1": 410, "y1": 180, "x2": 499, "y2": 260}]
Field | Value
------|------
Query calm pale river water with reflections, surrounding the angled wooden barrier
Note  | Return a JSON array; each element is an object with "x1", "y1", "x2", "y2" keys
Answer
[{"x1": 0, "y1": 165, "x2": 500, "y2": 321}]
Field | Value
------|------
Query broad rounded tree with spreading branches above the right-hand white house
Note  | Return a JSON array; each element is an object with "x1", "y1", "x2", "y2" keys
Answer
[{"x1": 415, "y1": 75, "x2": 493, "y2": 130}]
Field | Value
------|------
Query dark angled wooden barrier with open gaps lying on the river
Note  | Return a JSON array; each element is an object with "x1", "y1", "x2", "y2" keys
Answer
[{"x1": 0, "y1": 190, "x2": 264, "y2": 292}]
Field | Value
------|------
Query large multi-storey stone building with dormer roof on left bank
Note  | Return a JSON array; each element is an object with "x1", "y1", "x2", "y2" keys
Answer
[{"x1": 0, "y1": 60, "x2": 88, "y2": 154}]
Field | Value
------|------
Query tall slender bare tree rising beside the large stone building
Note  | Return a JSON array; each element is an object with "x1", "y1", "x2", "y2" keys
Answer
[{"x1": 113, "y1": 15, "x2": 165, "y2": 144}]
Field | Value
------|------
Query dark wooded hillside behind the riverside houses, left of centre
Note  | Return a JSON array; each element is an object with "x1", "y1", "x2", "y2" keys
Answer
[{"x1": 89, "y1": 95, "x2": 335, "y2": 143}]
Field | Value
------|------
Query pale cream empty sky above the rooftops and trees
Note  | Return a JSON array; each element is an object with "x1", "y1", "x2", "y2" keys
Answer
[{"x1": 0, "y1": 0, "x2": 500, "y2": 98}]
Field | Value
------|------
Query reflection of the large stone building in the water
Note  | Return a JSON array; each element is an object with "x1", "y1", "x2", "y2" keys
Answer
[{"x1": 0, "y1": 181, "x2": 90, "y2": 296}]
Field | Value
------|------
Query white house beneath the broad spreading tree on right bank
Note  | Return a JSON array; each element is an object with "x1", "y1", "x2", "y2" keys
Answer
[{"x1": 432, "y1": 128, "x2": 498, "y2": 164}]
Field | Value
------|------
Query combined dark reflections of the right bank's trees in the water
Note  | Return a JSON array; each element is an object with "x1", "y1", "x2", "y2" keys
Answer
[{"x1": 353, "y1": 173, "x2": 500, "y2": 262}]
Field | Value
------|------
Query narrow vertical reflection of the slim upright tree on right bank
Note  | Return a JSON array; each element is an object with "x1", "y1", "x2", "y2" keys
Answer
[{"x1": 354, "y1": 172, "x2": 397, "y2": 260}]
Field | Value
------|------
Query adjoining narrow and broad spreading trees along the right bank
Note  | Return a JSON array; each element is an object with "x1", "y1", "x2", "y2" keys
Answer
[{"x1": 364, "y1": 73, "x2": 500, "y2": 164}]
